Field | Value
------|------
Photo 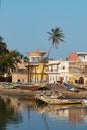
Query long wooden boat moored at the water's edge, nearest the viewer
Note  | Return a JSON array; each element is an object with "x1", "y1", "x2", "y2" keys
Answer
[{"x1": 36, "y1": 95, "x2": 82, "y2": 105}]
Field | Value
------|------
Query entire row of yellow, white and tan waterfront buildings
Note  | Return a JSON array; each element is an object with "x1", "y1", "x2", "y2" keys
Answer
[{"x1": 12, "y1": 50, "x2": 87, "y2": 84}]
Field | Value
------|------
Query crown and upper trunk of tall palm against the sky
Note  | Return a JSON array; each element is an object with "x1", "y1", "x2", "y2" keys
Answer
[{"x1": 47, "y1": 27, "x2": 64, "y2": 58}]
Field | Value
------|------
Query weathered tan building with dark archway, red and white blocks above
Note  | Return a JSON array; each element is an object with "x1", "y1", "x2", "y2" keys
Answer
[{"x1": 68, "y1": 52, "x2": 87, "y2": 84}]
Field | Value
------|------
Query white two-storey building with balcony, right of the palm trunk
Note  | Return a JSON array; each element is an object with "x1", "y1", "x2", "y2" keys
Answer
[{"x1": 48, "y1": 60, "x2": 69, "y2": 83}]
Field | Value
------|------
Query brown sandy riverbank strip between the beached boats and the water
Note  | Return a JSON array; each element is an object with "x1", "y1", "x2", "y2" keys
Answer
[{"x1": 0, "y1": 84, "x2": 87, "y2": 99}]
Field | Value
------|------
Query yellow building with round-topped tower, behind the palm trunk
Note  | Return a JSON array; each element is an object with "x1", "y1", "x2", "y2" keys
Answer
[{"x1": 28, "y1": 50, "x2": 48, "y2": 83}]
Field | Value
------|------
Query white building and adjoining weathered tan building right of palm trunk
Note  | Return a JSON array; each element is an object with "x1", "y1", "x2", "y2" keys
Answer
[{"x1": 48, "y1": 60, "x2": 87, "y2": 84}]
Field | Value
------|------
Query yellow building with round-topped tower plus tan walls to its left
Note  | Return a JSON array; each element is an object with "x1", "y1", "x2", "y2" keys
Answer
[{"x1": 12, "y1": 50, "x2": 48, "y2": 83}]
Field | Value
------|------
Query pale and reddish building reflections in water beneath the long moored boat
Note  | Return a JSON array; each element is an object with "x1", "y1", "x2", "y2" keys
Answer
[{"x1": 37, "y1": 101, "x2": 87, "y2": 124}]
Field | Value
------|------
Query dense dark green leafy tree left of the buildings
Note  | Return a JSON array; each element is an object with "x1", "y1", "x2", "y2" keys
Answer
[{"x1": 0, "y1": 36, "x2": 23, "y2": 79}]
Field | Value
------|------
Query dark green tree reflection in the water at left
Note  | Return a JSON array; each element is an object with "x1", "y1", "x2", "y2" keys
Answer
[{"x1": 0, "y1": 96, "x2": 22, "y2": 130}]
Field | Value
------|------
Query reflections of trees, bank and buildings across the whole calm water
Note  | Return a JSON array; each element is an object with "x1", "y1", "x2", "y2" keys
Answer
[{"x1": 0, "y1": 95, "x2": 87, "y2": 130}]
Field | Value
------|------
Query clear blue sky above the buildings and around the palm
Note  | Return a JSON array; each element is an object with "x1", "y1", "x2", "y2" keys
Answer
[{"x1": 0, "y1": 0, "x2": 87, "y2": 59}]
